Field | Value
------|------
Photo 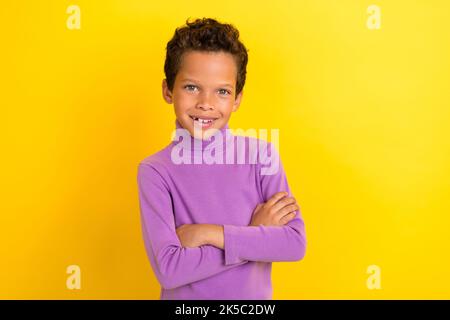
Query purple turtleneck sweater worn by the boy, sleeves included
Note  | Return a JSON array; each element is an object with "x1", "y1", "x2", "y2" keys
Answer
[{"x1": 137, "y1": 120, "x2": 306, "y2": 300}]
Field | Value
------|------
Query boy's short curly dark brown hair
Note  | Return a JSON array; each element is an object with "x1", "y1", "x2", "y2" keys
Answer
[{"x1": 164, "y1": 18, "x2": 249, "y2": 96}]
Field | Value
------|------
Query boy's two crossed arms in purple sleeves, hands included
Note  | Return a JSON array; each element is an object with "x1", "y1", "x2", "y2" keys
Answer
[{"x1": 138, "y1": 155, "x2": 306, "y2": 289}]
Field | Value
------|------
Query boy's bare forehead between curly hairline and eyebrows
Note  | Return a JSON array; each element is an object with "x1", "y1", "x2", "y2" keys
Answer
[{"x1": 178, "y1": 51, "x2": 237, "y2": 82}]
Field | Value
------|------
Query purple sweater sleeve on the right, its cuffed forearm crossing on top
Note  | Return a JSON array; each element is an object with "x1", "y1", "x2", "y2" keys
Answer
[{"x1": 224, "y1": 143, "x2": 306, "y2": 265}]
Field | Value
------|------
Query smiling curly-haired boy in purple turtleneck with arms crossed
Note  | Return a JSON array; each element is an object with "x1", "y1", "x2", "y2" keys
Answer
[{"x1": 138, "y1": 18, "x2": 306, "y2": 300}]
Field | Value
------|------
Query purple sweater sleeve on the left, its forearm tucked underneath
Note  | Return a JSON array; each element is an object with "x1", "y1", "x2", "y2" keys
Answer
[{"x1": 137, "y1": 163, "x2": 247, "y2": 289}]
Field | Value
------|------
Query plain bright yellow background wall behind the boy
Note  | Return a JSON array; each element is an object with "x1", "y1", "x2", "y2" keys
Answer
[{"x1": 0, "y1": 0, "x2": 450, "y2": 299}]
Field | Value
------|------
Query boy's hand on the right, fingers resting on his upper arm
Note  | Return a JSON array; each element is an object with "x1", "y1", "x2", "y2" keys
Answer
[{"x1": 250, "y1": 192, "x2": 299, "y2": 226}]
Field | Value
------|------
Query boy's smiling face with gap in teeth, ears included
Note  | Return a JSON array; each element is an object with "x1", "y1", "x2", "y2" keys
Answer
[{"x1": 163, "y1": 51, "x2": 243, "y2": 139}]
